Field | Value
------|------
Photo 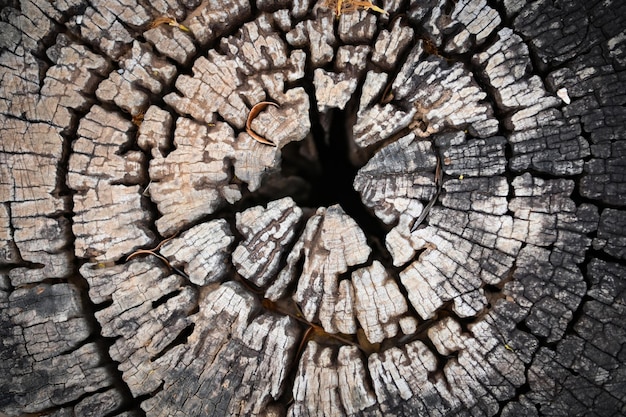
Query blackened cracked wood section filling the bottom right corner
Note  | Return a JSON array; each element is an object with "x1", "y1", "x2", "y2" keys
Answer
[{"x1": 528, "y1": 259, "x2": 626, "y2": 415}]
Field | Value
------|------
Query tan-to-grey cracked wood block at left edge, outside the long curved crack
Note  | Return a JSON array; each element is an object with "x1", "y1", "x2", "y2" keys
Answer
[{"x1": 0, "y1": 119, "x2": 72, "y2": 285}]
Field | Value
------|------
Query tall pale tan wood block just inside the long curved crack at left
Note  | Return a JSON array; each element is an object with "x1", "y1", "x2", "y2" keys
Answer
[{"x1": 67, "y1": 106, "x2": 152, "y2": 262}]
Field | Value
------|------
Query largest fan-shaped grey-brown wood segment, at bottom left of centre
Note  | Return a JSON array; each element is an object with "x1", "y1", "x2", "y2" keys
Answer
[{"x1": 88, "y1": 266, "x2": 298, "y2": 416}]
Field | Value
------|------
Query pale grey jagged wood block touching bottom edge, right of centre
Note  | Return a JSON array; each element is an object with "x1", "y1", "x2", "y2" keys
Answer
[{"x1": 369, "y1": 308, "x2": 525, "y2": 416}]
